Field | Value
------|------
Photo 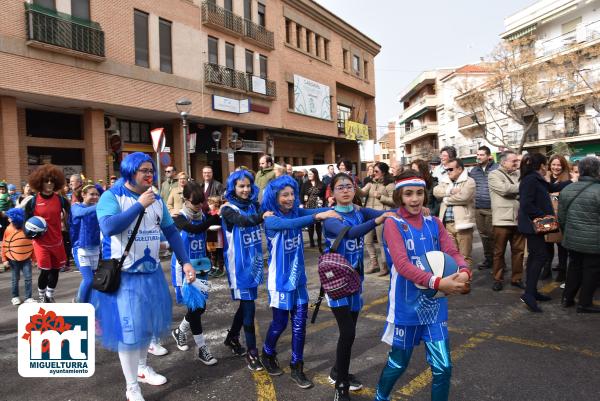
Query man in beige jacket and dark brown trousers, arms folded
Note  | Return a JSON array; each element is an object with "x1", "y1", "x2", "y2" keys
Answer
[{"x1": 488, "y1": 151, "x2": 525, "y2": 291}]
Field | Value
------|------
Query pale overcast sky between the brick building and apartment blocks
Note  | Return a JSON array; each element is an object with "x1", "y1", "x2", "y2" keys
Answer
[{"x1": 316, "y1": 0, "x2": 535, "y2": 136}]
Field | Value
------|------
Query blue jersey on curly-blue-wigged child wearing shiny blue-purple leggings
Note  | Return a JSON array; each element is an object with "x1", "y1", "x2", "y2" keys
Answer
[{"x1": 266, "y1": 216, "x2": 312, "y2": 292}]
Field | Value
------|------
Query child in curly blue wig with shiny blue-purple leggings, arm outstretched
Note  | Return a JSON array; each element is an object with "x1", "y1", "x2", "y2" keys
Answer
[{"x1": 260, "y1": 175, "x2": 340, "y2": 388}]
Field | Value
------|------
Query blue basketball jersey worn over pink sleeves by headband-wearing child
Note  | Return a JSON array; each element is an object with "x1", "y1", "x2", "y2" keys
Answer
[{"x1": 383, "y1": 216, "x2": 448, "y2": 326}]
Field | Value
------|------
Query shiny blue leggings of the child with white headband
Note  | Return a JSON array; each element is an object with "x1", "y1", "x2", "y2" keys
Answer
[{"x1": 375, "y1": 340, "x2": 452, "y2": 401}]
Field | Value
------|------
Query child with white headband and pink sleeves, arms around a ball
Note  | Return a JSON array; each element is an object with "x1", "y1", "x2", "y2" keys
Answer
[{"x1": 375, "y1": 170, "x2": 471, "y2": 401}]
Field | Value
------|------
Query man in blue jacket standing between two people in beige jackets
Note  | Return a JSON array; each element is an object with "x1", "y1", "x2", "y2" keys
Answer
[{"x1": 469, "y1": 146, "x2": 498, "y2": 270}]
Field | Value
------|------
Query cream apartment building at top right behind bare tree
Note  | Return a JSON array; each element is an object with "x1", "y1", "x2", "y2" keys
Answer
[{"x1": 501, "y1": 0, "x2": 600, "y2": 160}]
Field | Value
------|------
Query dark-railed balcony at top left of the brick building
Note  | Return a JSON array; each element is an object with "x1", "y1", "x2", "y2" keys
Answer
[{"x1": 25, "y1": 3, "x2": 104, "y2": 61}]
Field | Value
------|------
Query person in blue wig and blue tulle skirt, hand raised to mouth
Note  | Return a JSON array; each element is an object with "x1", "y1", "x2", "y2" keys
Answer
[{"x1": 91, "y1": 152, "x2": 195, "y2": 401}]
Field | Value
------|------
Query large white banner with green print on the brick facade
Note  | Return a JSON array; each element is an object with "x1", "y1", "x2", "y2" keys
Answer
[{"x1": 294, "y1": 75, "x2": 331, "y2": 120}]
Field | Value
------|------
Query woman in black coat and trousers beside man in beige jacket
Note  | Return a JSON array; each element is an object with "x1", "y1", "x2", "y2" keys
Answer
[{"x1": 518, "y1": 153, "x2": 571, "y2": 312}]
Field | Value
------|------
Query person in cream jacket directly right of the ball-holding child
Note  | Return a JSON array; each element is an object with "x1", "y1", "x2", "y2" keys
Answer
[{"x1": 433, "y1": 159, "x2": 475, "y2": 267}]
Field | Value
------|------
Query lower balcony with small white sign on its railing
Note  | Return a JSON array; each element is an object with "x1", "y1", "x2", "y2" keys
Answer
[{"x1": 204, "y1": 63, "x2": 277, "y2": 98}]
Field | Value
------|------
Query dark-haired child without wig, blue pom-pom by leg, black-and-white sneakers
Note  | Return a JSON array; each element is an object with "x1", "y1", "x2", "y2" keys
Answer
[{"x1": 171, "y1": 181, "x2": 221, "y2": 365}]
